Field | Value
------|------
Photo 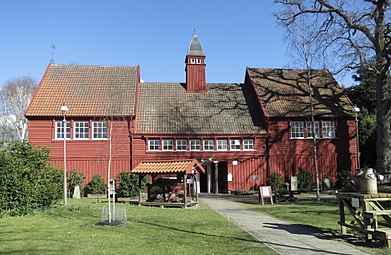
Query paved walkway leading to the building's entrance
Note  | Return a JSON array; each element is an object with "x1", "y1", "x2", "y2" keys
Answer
[{"x1": 200, "y1": 194, "x2": 367, "y2": 255}]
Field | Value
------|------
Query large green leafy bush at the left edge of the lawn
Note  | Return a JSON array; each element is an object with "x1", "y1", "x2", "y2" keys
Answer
[{"x1": 0, "y1": 141, "x2": 62, "y2": 216}]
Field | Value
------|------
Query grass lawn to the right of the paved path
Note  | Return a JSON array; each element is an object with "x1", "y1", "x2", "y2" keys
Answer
[{"x1": 240, "y1": 195, "x2": 391, "y2": 255}]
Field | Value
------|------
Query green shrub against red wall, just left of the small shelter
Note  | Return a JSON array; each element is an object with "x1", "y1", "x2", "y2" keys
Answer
[{"x1": 115, "y1": 171, "x2": 148, "y2": 197}]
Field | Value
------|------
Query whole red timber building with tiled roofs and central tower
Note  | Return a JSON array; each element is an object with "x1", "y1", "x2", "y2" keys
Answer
[{"x1": 26, "y1": 35, "x2": 357, "y2": 192}]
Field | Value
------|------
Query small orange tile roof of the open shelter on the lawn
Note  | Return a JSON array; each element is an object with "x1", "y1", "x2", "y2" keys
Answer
[{"x1": 131, "y1": 159, "x2": 205, "y2": 174}]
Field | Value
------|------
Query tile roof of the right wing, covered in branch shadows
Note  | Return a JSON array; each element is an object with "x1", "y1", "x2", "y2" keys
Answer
[{"x1": 247, "y1": 68, "x2": 353, "y2": 117}]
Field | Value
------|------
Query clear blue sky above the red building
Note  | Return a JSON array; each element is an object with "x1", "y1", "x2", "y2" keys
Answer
[{"x1": 0, "y1": 0, "x2": 356, "y2": 86}]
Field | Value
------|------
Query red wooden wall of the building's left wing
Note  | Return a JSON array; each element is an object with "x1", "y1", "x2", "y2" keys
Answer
[{"x1": 29, "y1": 119, "x2": 130, "y2": 182}]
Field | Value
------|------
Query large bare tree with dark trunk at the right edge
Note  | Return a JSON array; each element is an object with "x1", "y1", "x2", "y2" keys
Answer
[{"x1": 274, "y1": 0, "x2": 391, "y2": 173}]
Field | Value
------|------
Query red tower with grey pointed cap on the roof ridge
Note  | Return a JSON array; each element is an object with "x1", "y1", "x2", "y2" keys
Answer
[{"x1": 185, "y1": 33, "x2": 207, "y2": 92}]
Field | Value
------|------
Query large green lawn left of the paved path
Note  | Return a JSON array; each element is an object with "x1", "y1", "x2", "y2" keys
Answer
[{"x1": 0, "y1": 199, "x2": 276, "y2": 255}]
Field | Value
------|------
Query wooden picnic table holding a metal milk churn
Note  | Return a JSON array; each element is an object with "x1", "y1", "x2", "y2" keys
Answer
[{"x1": 337, "y1": 192, "x2": 391, "y2": 248}]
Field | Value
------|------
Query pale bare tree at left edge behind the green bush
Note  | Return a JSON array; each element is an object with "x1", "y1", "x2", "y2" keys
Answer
[{"x1": 0, "y1": 77, "x2": 37, "y2": 140}]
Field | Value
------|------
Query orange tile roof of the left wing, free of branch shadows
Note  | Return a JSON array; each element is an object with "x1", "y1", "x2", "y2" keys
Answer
[{"x1": 26, "y1": 64, "x2": 138, "y2": 117}]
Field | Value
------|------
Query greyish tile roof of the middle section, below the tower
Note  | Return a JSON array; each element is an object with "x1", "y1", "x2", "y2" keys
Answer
[{"x1": 136, "y1": 83, "x2": 265, "y2": 135}]
